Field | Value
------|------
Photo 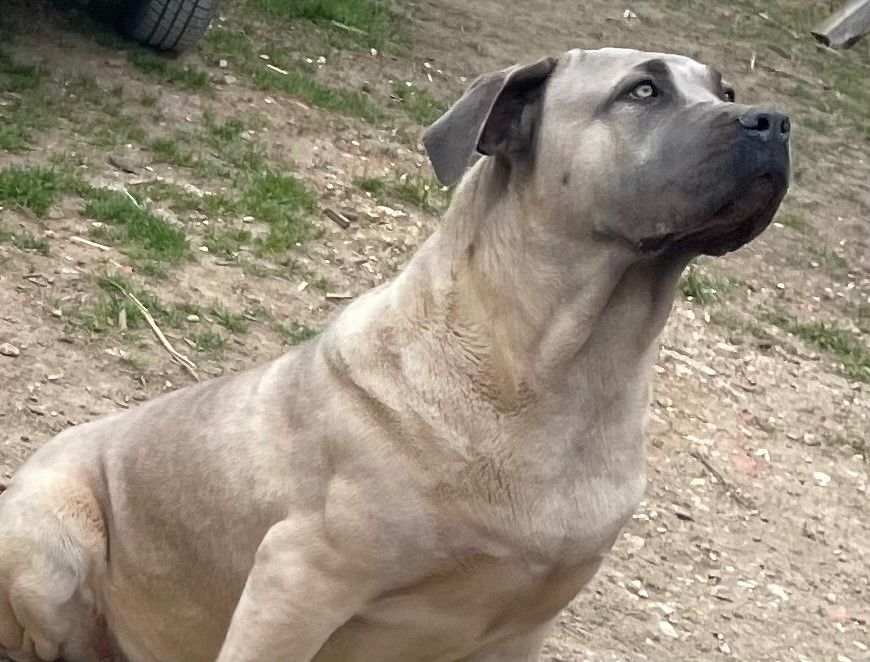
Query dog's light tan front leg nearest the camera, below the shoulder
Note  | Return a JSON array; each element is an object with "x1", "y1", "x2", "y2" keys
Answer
[{"x1": 217, "y1": 521, "x2": 370, "y2": 662}]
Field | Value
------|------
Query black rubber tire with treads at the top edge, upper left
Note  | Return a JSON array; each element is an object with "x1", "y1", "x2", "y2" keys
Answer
[{"x1": 126, "y1": 0, "x2": 218, "y2": 53}]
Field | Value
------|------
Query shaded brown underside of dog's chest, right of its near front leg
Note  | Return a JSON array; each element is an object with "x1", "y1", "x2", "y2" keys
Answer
[{"x1": 314, "y1": 555, "x2": 600, "y2": 662}]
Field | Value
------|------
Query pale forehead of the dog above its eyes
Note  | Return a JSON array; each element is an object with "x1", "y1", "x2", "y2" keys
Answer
[{"x1": 551, "y1": 48, "x2": 722, "y2": 101}]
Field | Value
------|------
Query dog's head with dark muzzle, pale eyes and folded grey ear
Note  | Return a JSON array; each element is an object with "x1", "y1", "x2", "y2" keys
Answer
[{"x1": 424, "y1": 49, "x2": 789, "y2": 256}]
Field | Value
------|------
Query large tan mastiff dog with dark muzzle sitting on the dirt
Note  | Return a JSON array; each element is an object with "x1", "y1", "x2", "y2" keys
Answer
[{"x1": 0, "y1": 49, "x2": 789, "y2": 662}]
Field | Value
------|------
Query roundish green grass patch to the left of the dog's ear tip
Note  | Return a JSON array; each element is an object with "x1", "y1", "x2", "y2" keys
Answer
[{"x1": 239, "y1": 170, "x2": 317, "y2": 253}]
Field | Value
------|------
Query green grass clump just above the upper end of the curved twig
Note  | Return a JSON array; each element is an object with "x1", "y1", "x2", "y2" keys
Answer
[{"x1": 85, "y1": 189, "x2": 189, "y2": 263}]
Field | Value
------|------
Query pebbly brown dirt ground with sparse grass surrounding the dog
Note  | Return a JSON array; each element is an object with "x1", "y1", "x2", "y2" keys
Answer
[{"x1": 0, "y1": 0, "x2": 870, "y2": 662}]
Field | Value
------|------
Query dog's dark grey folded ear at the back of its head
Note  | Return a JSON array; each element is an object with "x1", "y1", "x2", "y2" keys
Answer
[{"x1": 423, "y1": 58, "x2": 556, "y2": 186}]
